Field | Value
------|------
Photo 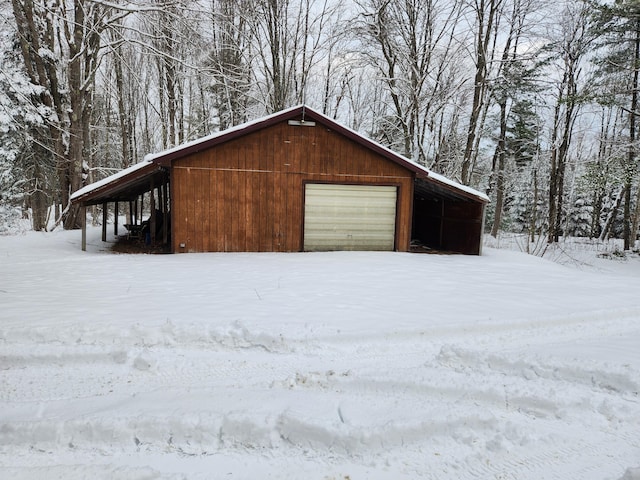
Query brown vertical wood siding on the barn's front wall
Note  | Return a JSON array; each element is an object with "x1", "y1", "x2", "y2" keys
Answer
[{"x1": 171, "y1": 121, "x2": 414, "y2": 252}]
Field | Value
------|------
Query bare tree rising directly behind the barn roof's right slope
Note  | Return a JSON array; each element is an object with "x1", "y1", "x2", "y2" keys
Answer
[{"x1": 356, "y1": 0, "x2": 465, "y2": 165}]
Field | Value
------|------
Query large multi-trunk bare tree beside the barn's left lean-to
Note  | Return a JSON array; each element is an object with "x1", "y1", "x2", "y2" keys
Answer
[{"x1": 12, "y1": 0, "x2": 166, "y2": 228}]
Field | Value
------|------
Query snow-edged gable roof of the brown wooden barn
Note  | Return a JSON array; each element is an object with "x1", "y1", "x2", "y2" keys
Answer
[{"x1": 71, "y1": 105, "x2": 489, "y2": 205}]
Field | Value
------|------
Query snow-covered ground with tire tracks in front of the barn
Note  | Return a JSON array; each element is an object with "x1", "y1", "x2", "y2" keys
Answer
[{"x1": 0, "y1": 230, "x2": 640, "y2": 480}]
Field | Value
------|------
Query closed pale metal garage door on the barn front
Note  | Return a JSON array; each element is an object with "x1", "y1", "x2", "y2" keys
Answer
[{"x1": 304, "y1": 183, "x2": 397, "y2": 251}]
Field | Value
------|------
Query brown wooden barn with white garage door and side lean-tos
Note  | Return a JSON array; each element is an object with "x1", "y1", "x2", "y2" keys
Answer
[{"x1": 72, "y1": 106, "x2": 488, "y2": 254}]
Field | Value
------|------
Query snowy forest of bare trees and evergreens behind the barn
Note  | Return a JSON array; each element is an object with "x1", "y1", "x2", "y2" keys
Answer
[{"x1": 0, "y1": 0, "x2": 640, "y2": 250}]
